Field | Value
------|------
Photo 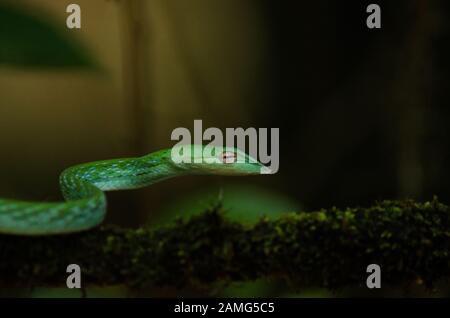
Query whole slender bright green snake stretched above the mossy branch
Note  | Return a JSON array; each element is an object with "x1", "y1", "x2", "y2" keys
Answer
[{"x1": 0, "y1": 145, "x2": 267, "y2": 235}]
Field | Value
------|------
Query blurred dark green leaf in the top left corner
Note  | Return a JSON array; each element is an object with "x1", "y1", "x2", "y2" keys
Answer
[{"x1": 0, "y1": 4, "x2": 94, "y2": 68}]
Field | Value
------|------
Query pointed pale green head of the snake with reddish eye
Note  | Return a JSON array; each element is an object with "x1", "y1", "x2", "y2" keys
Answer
[{"x1": 171, "y1": 145, "x2": 270, "y2": 175}]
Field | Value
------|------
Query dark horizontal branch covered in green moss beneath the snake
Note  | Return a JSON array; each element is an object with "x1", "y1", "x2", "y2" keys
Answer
[{"x1": 0, "y1": 199, "x2": 450, "y2": 288}]
